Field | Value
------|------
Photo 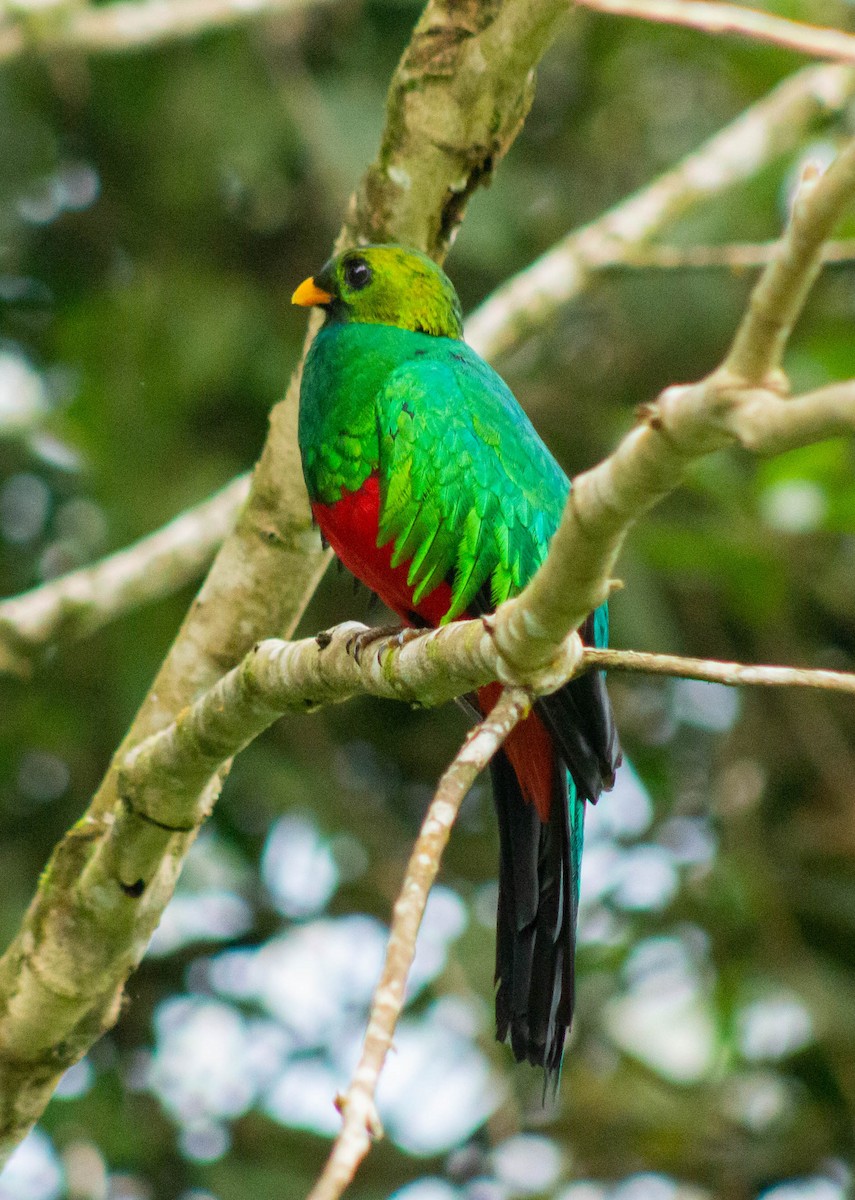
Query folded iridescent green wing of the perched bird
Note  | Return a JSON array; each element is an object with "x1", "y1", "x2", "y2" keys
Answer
[{"x1": 376, "y1": 342, "x2": 569, "y2": 620}]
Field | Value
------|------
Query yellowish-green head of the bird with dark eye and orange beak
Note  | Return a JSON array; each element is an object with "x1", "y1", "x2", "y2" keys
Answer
[{"x1": 291, "y1": 246, "x2": 464, "y2": 337}]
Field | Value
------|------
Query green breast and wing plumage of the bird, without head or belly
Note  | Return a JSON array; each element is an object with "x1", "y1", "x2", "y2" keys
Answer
[{"x1": 300, "y1": 322, "x2": 569, "y2": 620}]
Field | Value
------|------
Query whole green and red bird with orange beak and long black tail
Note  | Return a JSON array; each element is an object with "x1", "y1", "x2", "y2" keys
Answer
[{"x1": 293, "y1": 246, "x2": 621, "y2": 1079}]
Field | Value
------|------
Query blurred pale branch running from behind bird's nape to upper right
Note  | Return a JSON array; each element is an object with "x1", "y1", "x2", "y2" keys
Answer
[{"x1": 466, "y1": 66, "x2": 855, "y2": 359}]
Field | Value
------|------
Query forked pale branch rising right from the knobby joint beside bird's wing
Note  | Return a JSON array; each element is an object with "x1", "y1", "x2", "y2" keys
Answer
[{"x1": 494, "y1": 130, "x2": 855, "y2": 678}]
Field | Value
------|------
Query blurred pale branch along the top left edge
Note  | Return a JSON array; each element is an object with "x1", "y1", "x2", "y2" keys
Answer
[{"x1": 0, "y1": 0, "x2": 327, "y2": 62}]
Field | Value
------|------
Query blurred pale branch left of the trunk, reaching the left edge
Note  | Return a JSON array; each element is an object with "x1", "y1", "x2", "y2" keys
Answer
[{"x1": 0, "y1": 475, "x2": 250, "y2": 676}]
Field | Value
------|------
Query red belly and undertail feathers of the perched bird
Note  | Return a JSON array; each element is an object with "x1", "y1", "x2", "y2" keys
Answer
[{"x1": 312, "y1": 475, "x2": 557, "y2": 821}]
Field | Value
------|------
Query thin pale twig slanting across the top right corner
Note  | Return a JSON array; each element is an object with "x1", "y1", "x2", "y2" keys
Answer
[{"x1": 576, "y1": 0, "x2": 855, "y2": 62}]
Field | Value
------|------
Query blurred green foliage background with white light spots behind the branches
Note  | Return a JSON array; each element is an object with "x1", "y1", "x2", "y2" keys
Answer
[{"x1": 0, "y1": 0, "x2": 855, "y2": 1200}]
